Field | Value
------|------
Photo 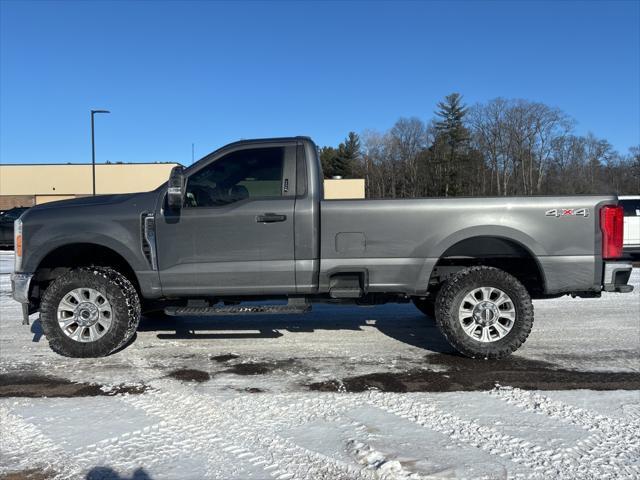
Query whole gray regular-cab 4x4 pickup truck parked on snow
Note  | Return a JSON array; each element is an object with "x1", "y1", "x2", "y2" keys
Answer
[{"x1": 12, "y1": 137, "x2": 632, "y2": 358}]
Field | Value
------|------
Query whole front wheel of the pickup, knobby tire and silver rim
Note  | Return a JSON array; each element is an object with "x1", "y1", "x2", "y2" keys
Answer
[{"x1": 40, "y1": 267, "x2": 140, "y2": 357}]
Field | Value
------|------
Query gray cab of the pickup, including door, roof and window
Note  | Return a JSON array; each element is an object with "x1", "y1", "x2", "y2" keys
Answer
[{"x1": 154, "y1": 138, "x2": 322, "y2": 296}]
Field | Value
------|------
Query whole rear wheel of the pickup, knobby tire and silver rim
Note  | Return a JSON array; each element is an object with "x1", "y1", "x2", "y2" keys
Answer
[{"x1": 435, "y1": 267, "x2": 533, "y2": 359}]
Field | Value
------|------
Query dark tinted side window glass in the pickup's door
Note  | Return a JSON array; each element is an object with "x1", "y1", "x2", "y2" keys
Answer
[{"x1": 185, "y1": 147, "x2": 286, "y2": 207}]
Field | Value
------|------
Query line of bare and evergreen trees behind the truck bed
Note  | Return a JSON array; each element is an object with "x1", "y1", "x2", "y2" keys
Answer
[{"x1": 320, "y1": 93, "x2": 640, "y2": 198}]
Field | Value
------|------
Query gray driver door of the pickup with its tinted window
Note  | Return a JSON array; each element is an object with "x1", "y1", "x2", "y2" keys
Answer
[{"x1": 157, "y1": 142, "x2": 296, "y2": 296}]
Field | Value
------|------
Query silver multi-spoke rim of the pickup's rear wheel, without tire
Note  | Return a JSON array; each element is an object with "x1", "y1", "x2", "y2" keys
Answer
[{"x1": 458, "y1": 287, "x2": 516, "y2": 342}]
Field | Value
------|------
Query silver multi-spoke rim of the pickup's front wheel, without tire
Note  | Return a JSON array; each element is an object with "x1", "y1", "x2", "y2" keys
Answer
[{"x1": 58, "y1": 288, "x2": 113, "y2": 342}]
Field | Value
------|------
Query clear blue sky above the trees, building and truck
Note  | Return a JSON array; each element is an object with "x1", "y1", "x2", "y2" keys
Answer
[{"x1": 0, "y1": 0, "x2": 640, "y2": 164}]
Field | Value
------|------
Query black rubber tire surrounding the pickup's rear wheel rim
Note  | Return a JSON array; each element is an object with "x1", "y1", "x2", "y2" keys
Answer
[{"x1": 435, "y1": 267, "x2": 533, "y2": 359}]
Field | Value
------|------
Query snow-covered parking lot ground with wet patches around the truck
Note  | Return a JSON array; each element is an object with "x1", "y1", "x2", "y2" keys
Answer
[{"x1": 0, "y1": 252, "x2": 640, "y2": 479}]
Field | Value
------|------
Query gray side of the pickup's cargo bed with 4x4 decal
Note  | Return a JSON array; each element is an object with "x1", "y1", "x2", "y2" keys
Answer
[{"x1": 320, "y1": 195, "x2": 616, "y2": 294}]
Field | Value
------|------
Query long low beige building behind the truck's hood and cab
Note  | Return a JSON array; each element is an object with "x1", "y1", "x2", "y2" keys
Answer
[{"x1": 0, "y1": 163, "x2": 364, "y2": 210}]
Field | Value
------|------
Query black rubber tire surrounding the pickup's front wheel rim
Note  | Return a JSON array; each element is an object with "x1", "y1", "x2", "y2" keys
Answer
[{"x1": 40, "y1": 267, "x2": 140, "y2": 357}]
